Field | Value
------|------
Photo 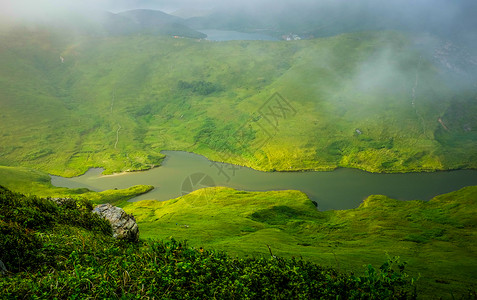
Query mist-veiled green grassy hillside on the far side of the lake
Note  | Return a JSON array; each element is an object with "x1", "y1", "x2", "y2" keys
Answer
[{"x1": 0, "y1": 30, "x2": 477, "y2": 176}]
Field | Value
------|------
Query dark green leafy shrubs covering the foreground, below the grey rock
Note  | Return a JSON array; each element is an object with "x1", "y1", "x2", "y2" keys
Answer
[{"x1": 0, "y1": 187, "x2": 414, "y2": 299}]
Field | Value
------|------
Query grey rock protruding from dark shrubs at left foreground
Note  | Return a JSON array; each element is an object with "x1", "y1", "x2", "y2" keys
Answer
[{"x1": 93, "y1": 203, "x2": 139, "y2": 241}]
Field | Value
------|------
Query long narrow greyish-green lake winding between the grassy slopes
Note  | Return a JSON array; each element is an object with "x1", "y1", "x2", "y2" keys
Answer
[{"x1": 51, "y1": 151, "x2": 477, "y2": 210}]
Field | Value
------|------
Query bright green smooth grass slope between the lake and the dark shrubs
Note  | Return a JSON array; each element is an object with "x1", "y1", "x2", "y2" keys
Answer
[{"x1": 125, "y1": 186, "x2": 477, "y2": 297}]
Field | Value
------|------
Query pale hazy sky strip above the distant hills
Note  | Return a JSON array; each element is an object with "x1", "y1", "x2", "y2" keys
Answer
[{"x1": 0, "y1": 0, "x2": 477, "y2": 43}]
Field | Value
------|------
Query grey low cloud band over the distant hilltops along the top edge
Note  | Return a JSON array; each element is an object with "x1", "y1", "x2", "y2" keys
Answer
[{"x1": 0, "y1": 0, "x2": 477, "y2": 46}]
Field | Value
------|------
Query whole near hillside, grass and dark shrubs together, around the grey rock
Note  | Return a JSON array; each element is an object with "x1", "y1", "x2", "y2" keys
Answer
[{"x1": 0, "y1": 182, "x2": 477, "y2": 299}]
